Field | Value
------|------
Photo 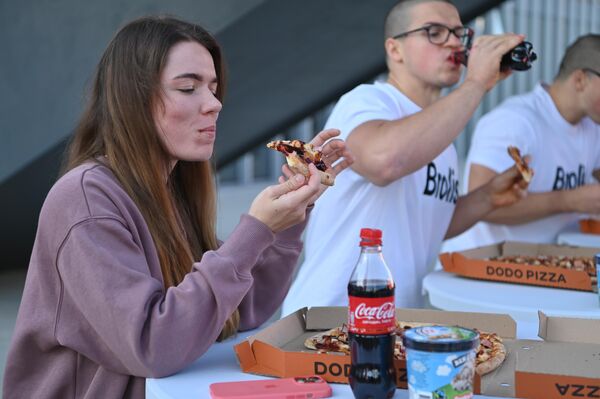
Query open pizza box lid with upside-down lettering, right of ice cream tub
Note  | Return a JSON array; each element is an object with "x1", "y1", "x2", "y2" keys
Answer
[{"x1": 481, "y1": 312, "x2": 600, "y2": 399}]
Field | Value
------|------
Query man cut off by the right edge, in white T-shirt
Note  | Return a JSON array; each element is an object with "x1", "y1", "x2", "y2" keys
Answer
[{"x1": 450, "y1": 34, "x2": 600, "y2": 253}]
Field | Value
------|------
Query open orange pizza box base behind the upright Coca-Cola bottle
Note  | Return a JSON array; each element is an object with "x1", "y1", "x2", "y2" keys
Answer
[{"x1": 234, "y1": 307, "x2": 516, "y2": 393}]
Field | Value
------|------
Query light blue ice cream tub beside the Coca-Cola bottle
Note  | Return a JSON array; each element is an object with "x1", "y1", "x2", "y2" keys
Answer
[{"x1": 403, "y1": 326, "x2": 479, "y2": 399}]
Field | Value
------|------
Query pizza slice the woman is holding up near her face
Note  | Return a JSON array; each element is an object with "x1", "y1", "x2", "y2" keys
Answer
[{"x1": 267, "y1": 140, "x2": 334, "y2": 186}]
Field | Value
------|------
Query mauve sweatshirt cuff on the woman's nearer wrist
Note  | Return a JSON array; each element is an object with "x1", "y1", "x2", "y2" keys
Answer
[{"x1": 219, "y1": 214, "x2": 275, "y2": 274}]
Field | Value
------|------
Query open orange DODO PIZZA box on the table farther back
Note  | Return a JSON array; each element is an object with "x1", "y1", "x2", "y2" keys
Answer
[{"x1": 439, "y1": 241, "x2": 600, "y2": 292}]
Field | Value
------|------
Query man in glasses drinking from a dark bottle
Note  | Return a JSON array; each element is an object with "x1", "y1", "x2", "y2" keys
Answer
[{"x1": 283, "y1": 0, "x2": 524, "y2": 314}]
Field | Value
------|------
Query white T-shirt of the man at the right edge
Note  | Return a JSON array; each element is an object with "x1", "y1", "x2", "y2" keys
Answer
[{"x1": 444, "y1": 84, "x2": 600, "y2": 250}]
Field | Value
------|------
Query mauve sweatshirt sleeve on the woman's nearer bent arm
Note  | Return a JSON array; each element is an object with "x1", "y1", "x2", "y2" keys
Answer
[{"x1": 54, "y1": 212, "x2": 274, "y2": 377}]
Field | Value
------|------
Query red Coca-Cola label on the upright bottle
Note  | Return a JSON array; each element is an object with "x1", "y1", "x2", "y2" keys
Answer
[{"x1": 348, "y1": 296, "x2": 396, "y2": 335}]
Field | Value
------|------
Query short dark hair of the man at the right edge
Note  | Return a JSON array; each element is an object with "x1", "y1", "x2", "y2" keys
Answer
[{"x1": 556, "y1": 34, "x2": 600, "y2": 80}]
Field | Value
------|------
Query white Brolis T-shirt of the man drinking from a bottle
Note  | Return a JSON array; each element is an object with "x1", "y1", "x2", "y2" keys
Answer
[{"x1": 283, "y1": 83, "x2": 458, "y2": 315}]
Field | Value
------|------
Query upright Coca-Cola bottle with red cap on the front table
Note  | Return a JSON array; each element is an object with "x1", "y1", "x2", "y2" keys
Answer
[{"x1": 348, "y1": 229, "x2": 396, "y2": 399}]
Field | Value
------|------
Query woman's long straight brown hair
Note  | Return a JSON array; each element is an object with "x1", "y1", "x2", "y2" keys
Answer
[{"x1": 64, "y1": 17, "x2": 239, "y2": 339}]
